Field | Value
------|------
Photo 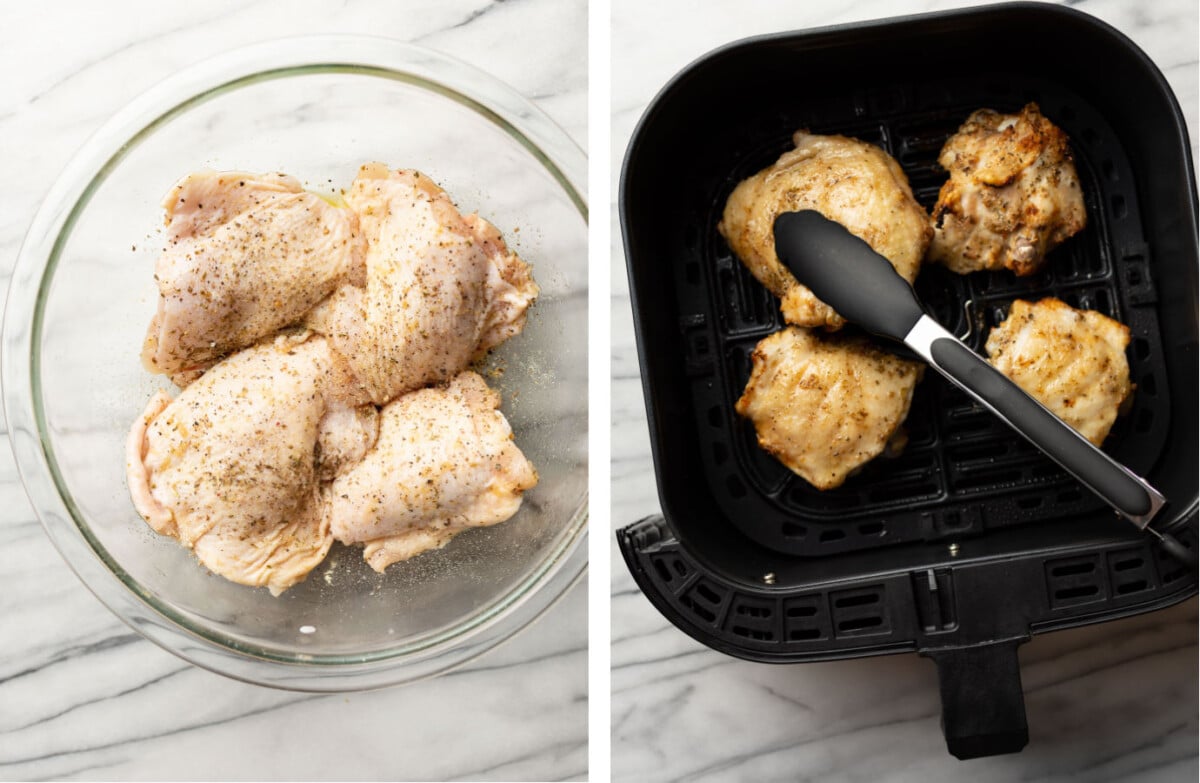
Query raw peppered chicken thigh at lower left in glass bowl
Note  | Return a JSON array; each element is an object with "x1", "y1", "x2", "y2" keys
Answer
[{"x1": 126, "y1": 334, "x2": 376, "y2": 594}]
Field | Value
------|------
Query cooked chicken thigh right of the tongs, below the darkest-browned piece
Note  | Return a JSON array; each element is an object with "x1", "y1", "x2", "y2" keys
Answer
[{"x1": 986, "y1": 299, "x2": 1133, "y2": 446}]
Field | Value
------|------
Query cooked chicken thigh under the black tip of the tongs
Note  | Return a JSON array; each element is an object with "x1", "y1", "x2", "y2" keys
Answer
[{"x1": 718, "y1": 131, "x2": 932, "y2": 329}]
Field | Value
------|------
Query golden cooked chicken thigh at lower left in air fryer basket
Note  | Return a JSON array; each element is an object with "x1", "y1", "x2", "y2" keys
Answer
[{"x1": 737, "y1": 327, "x2": 923, "y2": 490}]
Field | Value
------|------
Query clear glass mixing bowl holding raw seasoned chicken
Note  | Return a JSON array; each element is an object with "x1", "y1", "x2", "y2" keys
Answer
[{"x1": 2, "y1": 36, "x2": 587, "y2": 691}]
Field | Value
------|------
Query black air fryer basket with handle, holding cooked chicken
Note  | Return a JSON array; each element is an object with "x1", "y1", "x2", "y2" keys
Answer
[{"x1": 618, "y1": 4, "x2": 1200, "y2": 758}]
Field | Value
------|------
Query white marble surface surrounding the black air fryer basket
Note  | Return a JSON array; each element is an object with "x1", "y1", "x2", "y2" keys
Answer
[{"x1": 610, "y1": 0, "x2": 1200, "y2": 783}]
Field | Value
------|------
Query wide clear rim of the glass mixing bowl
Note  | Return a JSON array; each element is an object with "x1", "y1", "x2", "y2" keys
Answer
[{"x1": 0, "y1": 35, "x2": 588, "y2": 692}]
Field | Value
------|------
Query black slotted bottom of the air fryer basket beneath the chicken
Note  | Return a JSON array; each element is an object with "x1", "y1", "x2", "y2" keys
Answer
[{"x1": 677, "y1": 77, "x2": 1170, "y2": 556}]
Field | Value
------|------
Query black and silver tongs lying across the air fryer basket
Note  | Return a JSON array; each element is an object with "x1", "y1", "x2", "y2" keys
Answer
[{"x1": 774, "y1": 210, "x2": 1196, "y2": 568}]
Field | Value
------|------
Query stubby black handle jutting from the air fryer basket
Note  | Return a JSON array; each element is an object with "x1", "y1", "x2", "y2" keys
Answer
[{"x1": 922, "y1": 639, "x2": 1030, "y2": 759}]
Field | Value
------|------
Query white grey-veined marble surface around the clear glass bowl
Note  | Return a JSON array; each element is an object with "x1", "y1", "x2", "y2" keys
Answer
[{"x1": 0, "y1": 0, "x2": 587, "y2": 781}]
